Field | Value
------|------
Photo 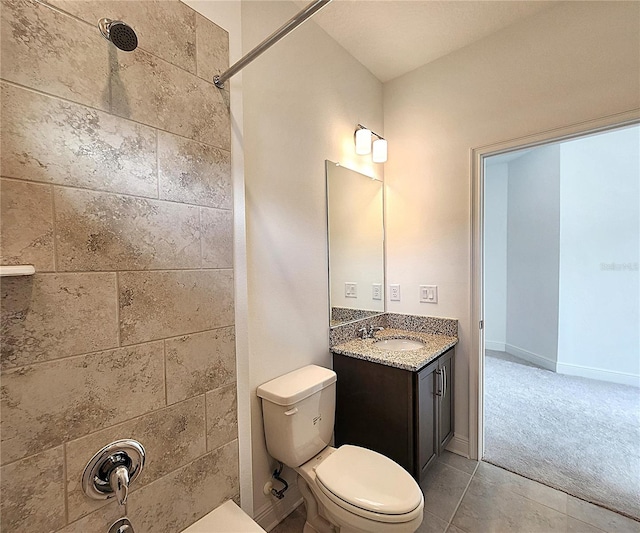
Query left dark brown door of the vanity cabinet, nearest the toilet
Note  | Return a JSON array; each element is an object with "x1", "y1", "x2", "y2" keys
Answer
[{"x1": 416, "y1": 362, "x2": 438, "y2": 480}]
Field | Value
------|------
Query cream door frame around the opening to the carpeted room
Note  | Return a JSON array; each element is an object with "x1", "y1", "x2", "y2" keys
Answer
[{"x1": 469, "y1": 109, "x2": 640, "y2": 460}]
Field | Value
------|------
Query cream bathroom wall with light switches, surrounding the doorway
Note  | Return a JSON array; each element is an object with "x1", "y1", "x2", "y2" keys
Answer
[{"x1": 384, "y1": 2, "x2": 640, "y2": 454}]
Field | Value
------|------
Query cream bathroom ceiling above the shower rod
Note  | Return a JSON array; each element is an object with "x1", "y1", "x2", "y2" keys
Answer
[{"x1": 296, "y1": 0, "x2": 554, "y2": 82}]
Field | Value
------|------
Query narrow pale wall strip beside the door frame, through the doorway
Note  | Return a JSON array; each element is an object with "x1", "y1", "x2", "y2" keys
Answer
[{"x1": 484, "y1": 164, "x2": 509, "y2": 352}]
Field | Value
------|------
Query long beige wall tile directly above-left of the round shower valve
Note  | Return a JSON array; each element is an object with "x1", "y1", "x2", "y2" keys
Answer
[{"x1": 0, "y1": 342, "x2": 165, "y2": 464}]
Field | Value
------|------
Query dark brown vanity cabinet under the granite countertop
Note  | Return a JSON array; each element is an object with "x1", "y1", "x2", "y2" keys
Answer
[{"x1": 333, "y1": 348, "x2": 454, "y2": 482}]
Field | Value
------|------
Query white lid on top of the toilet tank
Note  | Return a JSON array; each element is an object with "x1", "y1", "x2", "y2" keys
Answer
[{"x1": 256, "y1": 365, "x2": 336, "y2": 406}]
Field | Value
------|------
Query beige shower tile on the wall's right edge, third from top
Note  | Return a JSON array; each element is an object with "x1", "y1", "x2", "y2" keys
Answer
[{"x1": 158, "y1": 131, "x2": 233, "y2": 209}]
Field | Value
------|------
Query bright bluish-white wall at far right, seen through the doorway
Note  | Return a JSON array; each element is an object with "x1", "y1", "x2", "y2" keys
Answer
[{"x1": 558, "y1": 126, "x2": 640, "y2": 385}]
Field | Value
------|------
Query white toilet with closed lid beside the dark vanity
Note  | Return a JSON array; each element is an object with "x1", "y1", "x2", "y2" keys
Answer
[{"x1": 257, "y1": 365, "x2": 424, "y2": 533}]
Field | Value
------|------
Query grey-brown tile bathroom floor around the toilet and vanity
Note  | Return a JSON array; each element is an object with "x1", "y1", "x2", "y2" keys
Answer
[{"x1": 272, "y1": 452, "x2": 640, "y2": 533}]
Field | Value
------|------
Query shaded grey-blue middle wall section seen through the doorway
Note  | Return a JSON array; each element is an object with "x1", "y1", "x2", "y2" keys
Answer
[{"x1": 506, "y1": 144, "x2": 560, "y2": 371}]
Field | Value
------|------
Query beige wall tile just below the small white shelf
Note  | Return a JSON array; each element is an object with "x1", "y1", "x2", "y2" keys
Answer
[{"x1": 0, "y1": 273, "x2": 118, "y2": 368}]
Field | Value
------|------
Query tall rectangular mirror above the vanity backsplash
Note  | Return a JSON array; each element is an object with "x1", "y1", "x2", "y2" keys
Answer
[{"x1": 326, "y1": 161, "x2": 385, "y2": 327}]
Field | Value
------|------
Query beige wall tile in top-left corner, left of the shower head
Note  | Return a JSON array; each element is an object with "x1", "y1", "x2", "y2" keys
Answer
[{"x1": 0, "y1": 0, "x2": 109, "y2": 110}]
